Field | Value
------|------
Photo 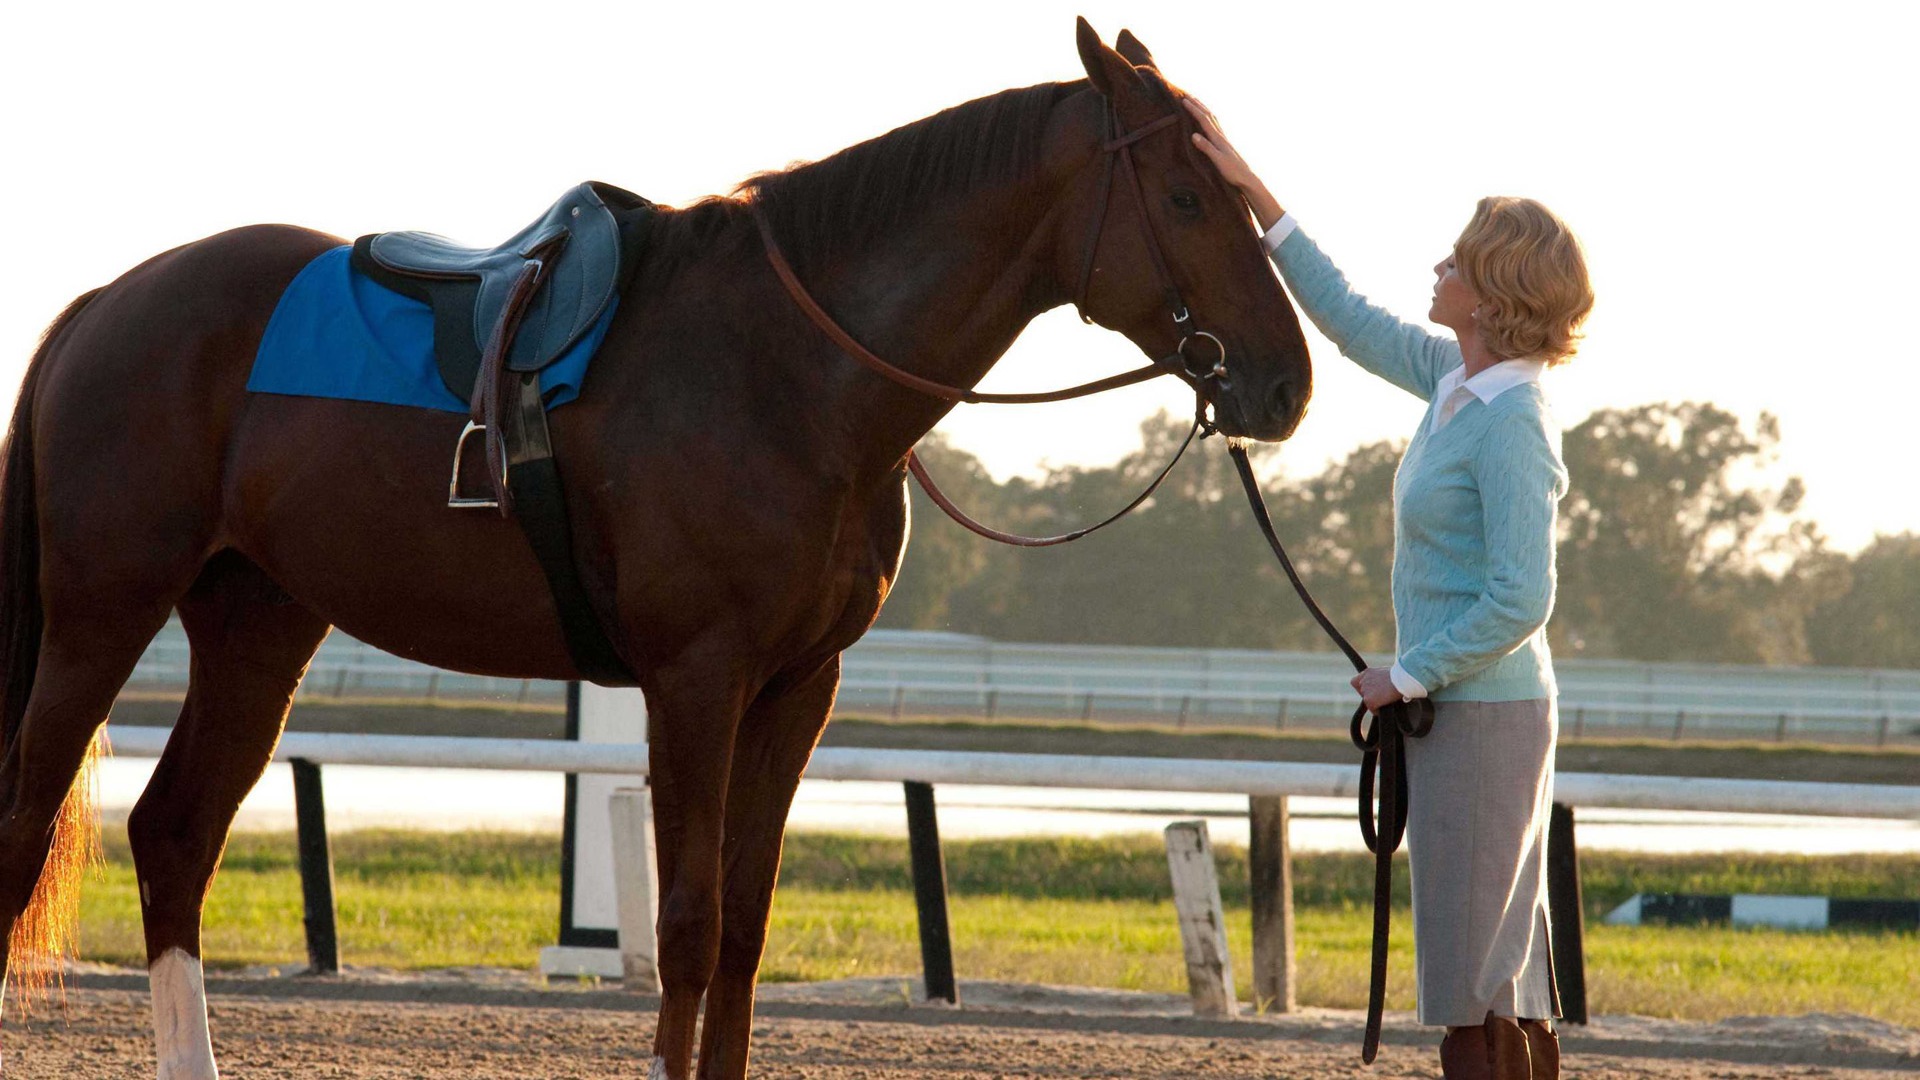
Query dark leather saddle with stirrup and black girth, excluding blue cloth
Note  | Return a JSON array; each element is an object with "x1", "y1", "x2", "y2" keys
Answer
[{"x1": 351, "y1": 181, "x2": 655, "y2": 686}]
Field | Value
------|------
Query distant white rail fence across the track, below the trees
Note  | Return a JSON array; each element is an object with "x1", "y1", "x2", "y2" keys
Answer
[{"x1": 132, "y1": 625, "x2": 1920, "y2": 746}]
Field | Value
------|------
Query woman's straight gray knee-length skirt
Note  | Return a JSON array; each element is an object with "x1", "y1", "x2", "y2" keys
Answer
[{"x1": 1407, "y1": 700, "x2": 1559, "y2": 1026}]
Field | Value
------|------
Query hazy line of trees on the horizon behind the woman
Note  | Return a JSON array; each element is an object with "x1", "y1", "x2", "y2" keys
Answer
[{"x1": 877, "y1": 402, "x2": 1920, "y2": 669}]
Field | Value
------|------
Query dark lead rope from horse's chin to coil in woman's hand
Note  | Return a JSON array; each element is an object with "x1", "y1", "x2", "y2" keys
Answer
[{"x1": 1227, "y1": 444, "x2": 1434, "y2": 1065}]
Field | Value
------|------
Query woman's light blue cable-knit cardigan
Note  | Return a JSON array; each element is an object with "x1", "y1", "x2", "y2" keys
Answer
[{"x1": 1273, "y1": 229, "x2": 1567, "y2": 701}]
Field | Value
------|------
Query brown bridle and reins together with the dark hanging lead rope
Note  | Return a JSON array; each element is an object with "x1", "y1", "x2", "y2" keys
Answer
[{"x1": 753, "y1": 92, "x2": 1434, "y2": 1065}]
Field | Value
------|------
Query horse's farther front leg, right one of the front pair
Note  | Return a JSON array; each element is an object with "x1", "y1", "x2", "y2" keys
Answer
[{"x1": 701, "y1": 657, "x2": 841, "y2": 1080}]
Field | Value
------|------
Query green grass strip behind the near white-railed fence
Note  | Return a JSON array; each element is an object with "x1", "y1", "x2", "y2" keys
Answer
[{"x1": 67, "y1": 830, "x2": 1920, "y2": 1026}]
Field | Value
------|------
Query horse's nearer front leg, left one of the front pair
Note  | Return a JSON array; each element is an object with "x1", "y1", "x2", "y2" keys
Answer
[{"x1": 645, "y1": 648, "x2": 751, "y2": 1080}]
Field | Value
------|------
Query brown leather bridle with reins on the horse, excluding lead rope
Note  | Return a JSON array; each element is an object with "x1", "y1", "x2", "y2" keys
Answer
[{"x1": 753, "y1": 96, "x2": 1233, "y2": 548}]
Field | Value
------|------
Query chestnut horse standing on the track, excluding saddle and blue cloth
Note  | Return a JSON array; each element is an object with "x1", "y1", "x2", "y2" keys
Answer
[{"x1": 0, "y1": 21, "x2": 1311, "y2": 1080}]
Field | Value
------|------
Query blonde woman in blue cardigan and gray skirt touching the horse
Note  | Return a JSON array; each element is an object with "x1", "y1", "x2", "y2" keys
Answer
[{"x1": 1188, "y1": 100, "x2": 1594, "y2": 1080}]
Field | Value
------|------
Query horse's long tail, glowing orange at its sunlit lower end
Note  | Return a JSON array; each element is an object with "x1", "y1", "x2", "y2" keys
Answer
[{"x1": 0, "y1": 288, "x2": 104, "y2": 1009}]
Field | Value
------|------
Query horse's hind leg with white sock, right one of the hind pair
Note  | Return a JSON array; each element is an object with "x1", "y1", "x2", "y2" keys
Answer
[{"x1": 127, "y1": 552, "x2": 328, "y2": 1080}]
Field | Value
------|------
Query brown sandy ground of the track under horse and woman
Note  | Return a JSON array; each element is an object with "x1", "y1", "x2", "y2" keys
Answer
[{"x1": 4, "y1": 969, "x2": 1920, "y2": 1080}]
